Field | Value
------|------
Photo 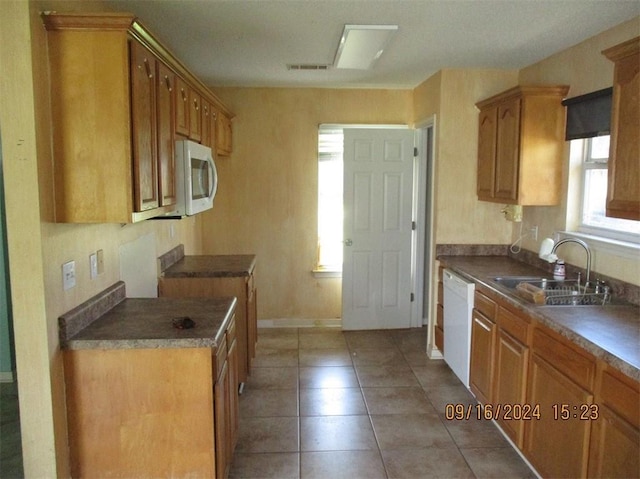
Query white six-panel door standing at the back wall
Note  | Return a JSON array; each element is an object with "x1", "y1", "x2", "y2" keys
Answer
[{"x1": 342, "y1": 129, "x2": 414, "y2": 330}]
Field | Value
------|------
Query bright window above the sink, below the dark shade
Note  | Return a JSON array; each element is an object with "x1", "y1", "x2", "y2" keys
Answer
[{"x1": 574, "y1": 135, "x2": 640, "y2": 243}]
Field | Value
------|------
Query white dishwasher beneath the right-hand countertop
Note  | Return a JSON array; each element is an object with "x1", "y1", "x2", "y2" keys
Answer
[{"x1": 443, "y1": 269, "x2": 475, "y2": 388}]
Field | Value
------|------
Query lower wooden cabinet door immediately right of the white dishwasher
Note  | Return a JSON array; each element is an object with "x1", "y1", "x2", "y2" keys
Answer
[{"x1": 469, "y1": 309, "x2": 496, "y2": 404}]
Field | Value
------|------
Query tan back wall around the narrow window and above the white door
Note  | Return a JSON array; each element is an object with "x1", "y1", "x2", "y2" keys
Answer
[{"x1": 203, "y1": 88, "x2": 412, "y2": 319}]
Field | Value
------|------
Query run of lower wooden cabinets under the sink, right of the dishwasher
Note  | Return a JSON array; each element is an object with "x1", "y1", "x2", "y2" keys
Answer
[{"x1": 469, "y1": 287, "x2": 640, "y2": 478}]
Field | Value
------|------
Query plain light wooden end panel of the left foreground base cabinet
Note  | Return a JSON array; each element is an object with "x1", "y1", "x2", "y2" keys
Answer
[{"x1": 63, "y1": 348, "x2": 215, "y2": 477}]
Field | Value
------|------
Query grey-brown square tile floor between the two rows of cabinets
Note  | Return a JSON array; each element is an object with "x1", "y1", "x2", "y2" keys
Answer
[{"x1": 230, "y1": 328, "x2": 536, "y2": 479}]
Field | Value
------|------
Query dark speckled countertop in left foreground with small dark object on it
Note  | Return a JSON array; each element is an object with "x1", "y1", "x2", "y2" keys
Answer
[{"x1": 59, "y1": 282, "x2": 236, "y2": 349}]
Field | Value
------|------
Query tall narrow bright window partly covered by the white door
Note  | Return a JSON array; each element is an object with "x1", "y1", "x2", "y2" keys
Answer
[{"x1": 317, "y1": 125, "x2": 344, "y2": 272}]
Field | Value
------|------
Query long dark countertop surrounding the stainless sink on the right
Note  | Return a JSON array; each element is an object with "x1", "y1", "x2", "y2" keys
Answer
[{"x1": 438, "y1": 256, "x2": 640, "y2": 380}]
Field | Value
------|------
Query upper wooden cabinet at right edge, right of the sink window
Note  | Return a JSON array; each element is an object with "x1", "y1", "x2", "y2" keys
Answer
[{"x1": 602, "y1": 37, "x2": 640, "y2": 220}]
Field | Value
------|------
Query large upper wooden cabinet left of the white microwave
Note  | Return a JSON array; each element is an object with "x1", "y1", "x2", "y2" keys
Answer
[{"x1": 42, "y1": 13, "x2": 232, "y2": 223}]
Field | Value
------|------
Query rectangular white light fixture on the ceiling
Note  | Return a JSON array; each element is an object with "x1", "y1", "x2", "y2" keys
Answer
[{"x1": 333, "y1": 25, "x2": 398, "y2": 70}]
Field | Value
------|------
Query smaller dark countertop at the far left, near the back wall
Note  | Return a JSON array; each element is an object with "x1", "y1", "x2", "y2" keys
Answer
[{"x1": 158, "y1": 245, "x2": 256, "y2": 278}]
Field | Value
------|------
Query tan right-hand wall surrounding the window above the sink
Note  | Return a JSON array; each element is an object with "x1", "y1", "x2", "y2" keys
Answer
[{"x1": 514, "y1": 17, "x2": 640, "y2": 284}]
